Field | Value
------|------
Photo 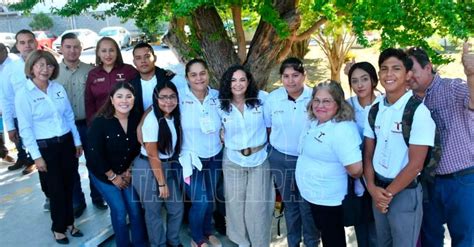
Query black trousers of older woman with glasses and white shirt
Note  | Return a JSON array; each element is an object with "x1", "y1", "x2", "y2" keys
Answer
[{"x1": 310, "y1": 203, "x2": 346, "y2": 247}]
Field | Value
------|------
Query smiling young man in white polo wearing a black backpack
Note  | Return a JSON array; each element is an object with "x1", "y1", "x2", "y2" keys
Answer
[{"x1": 364, "y1": 48, "x2": 436, "y2": 247}]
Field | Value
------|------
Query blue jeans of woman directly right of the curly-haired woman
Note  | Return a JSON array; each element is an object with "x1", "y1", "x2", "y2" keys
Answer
[{"x1": 268, "y1": 148, "x2": 319, "y2": 247}]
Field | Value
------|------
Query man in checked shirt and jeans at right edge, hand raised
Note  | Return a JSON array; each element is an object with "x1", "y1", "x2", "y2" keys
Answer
[{"x1": 407, "y1": 43, "x2": 474, "y2": 247}]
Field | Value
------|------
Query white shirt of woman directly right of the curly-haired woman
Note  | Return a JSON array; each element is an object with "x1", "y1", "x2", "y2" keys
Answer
[{"x1": 263, "y1": 85, "x2": 312, "y2": 156}]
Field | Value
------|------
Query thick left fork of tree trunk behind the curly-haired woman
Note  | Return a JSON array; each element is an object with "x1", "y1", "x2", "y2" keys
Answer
[{"x1": 192, "y1": 6, "x2": 240, "y2": 85}]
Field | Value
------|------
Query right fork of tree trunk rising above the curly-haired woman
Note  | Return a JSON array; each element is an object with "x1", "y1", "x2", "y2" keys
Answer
[{"x1": 244, "y1": 0, "x2": 301, "y2": 89}]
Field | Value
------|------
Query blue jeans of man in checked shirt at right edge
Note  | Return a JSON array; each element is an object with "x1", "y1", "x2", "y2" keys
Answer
[{"x1": 421, "y1": 168, "x2": 474, "y2": 247}]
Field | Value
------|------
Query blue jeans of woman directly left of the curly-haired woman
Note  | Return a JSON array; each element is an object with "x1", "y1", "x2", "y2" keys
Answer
[{"x1": 180, "y1": 151, "x2": 222, "y2": 243}]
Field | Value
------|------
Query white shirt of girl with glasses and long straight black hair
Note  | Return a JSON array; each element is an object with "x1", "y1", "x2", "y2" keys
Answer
[{"x1": 140, "y1": 111, "x2": 178, "y2": 159}]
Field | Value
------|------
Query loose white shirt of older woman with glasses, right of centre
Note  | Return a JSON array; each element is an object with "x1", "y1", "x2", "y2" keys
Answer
[{"x1": 295, "y1": 120, "x2": 362, "y2": 206}]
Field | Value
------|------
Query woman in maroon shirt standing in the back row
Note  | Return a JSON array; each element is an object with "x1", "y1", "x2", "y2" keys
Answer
[{"x1": 85, "y1": 37, "x2": 138, "y2": 123}]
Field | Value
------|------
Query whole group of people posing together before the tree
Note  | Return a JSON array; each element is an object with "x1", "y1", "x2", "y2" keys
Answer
[{"x1": 0, "y1": 26, "x2": 474, "y2": 247}]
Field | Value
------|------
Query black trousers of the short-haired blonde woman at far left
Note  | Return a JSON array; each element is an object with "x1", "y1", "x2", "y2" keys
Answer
[{"x1": 36, "y1": 132, "x2": 78, "y2": 232}]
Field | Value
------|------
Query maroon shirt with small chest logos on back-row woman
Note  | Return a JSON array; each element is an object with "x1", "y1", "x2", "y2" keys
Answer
[{"x1": 85, "y1": 64, "x2": 138, "y2": 123}]
